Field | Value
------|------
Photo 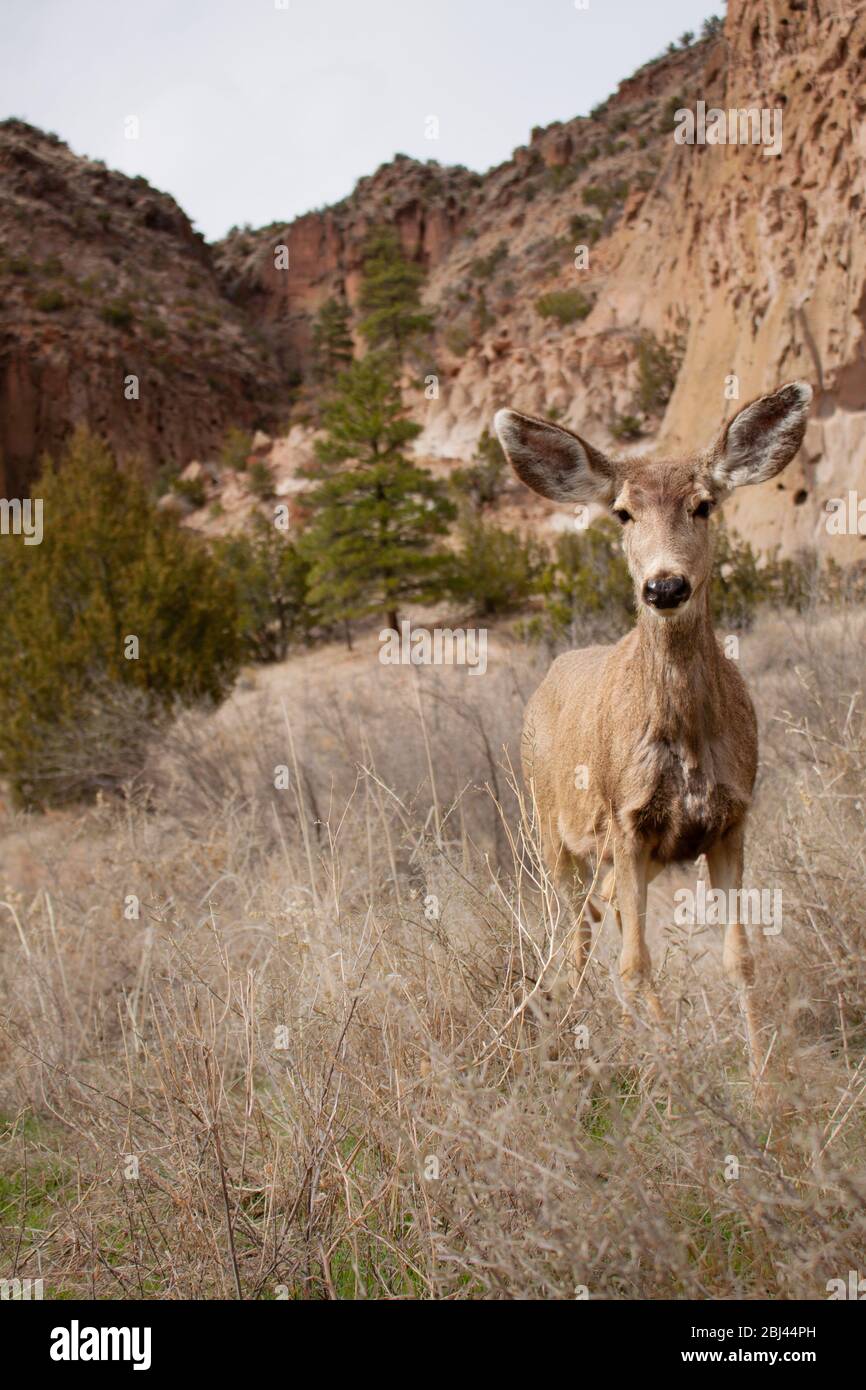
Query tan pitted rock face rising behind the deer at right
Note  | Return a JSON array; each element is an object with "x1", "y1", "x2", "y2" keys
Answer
[{"x1": 400, "y1": 0, "x2": 866, "y2": 559}]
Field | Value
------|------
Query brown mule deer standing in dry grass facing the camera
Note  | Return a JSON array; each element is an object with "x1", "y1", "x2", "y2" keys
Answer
[{"x1": 493, "y1": 381, "x2": 812, "y2": 1077}]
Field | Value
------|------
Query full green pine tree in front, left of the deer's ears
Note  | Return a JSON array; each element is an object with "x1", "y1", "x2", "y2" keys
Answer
[{"x1": 300, "y1": 353, "x2": 455, "y2": 628}]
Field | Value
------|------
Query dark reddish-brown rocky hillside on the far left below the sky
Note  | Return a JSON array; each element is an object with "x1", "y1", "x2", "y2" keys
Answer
[{"x1": 0, "y1": 121, "x2": 281, "y2": 496}]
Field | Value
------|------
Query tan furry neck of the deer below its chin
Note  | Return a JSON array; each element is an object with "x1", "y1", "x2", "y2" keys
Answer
[{"x1": 637, "y1": 589, "x2": 724, "y2": 749}]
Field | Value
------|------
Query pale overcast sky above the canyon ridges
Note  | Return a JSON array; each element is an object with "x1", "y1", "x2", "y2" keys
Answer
[{"x1": 0, "y1": 0, "x2": 723, "y2": 239}]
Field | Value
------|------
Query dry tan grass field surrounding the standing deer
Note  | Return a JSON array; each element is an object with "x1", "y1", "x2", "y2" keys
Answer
[{"x1": 0, "y1": 612, "x2": 866, "y2": 1298}]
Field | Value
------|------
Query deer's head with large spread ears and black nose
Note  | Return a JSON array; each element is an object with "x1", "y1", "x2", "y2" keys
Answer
[{"x1": 495, "y1": 381, "x2": 812, "y2": 619}]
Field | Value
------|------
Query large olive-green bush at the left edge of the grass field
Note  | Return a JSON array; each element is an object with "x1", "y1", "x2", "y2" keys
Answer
[{"x1": 0, "y1": 431, "x2": 239, "y2": 806}]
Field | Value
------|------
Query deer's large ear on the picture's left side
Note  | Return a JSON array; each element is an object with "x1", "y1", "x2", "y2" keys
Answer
[{"x1": 493, "y1": 410, "x2": 616, "y2": 503}]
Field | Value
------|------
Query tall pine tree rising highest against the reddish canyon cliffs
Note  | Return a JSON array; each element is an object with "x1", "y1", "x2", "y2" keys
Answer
[{"x1": 359, "y1": 227, "x2": 434, "y2": 357}]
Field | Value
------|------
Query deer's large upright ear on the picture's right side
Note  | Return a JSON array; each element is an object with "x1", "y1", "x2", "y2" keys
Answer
[{"x1": 712, "y1": 381, "x2": 812, "y2": 488}]
